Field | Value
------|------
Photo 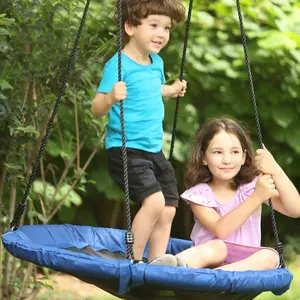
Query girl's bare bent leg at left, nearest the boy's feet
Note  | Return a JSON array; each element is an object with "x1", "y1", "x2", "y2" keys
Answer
[{"x1": 176, "y1": 240, "x2": 227, "y2": 269}]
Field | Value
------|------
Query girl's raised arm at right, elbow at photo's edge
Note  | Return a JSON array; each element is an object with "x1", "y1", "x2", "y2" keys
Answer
[{"x1": 255, "y1": 147, "x2": 300, "y2": 218}]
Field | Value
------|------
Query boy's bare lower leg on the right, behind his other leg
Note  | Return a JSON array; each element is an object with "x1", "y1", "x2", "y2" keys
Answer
[{"x1": 148, "y1": 206, "x2": 176, "y2": 261}]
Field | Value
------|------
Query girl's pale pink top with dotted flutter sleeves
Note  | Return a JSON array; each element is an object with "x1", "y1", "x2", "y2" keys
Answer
[{"x1": 181, "y1": 178, "x2": 261, "y2": 247}]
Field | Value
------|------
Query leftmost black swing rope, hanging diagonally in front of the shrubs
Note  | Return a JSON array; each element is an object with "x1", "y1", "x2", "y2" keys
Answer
[{"x1": 10, "y1": 0, "x2": 91, "y2": 230}]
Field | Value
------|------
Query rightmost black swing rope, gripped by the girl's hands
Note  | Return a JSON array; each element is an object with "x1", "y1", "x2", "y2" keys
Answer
[{"x1": 236, "y1": 0, "x2": 285, "y2": 268}]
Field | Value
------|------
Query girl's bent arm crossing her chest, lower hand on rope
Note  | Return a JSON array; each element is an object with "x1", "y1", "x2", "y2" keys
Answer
[{"x1": 190, "y1": 174, "x2": 278, "y2": 239}]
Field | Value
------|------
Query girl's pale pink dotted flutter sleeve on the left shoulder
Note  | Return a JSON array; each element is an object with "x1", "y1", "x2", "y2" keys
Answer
[{"x1": 181, "y1": 183, "x2": 218, "y2": 208}]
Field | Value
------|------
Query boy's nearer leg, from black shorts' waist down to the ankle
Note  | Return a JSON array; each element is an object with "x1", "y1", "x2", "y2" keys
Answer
[{"x1": 107, "y1": 148, "x2": 165, "y2": 260}]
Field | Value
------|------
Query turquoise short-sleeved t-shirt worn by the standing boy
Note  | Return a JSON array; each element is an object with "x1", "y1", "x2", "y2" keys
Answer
[{"x1": 97, "y1": 53, "x2": 165, "y2": 152}]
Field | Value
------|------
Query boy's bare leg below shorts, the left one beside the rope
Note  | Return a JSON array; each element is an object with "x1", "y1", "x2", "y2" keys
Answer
[{"x1": 132, "y1": 192, "x2": 166, "y2": 260}]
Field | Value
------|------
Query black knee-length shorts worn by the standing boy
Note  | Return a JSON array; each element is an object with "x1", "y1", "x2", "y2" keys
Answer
[{"x1": 107, "y1": 148, "x2": 179, "y2": 207}]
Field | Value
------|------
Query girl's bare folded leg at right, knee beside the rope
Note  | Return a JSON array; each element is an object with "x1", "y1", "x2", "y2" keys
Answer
[{"x1": 217, "y1": 249, "x2": 279, "y2": 271}]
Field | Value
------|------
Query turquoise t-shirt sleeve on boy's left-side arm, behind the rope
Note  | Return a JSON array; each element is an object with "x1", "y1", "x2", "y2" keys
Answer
[{"x1": 97, "y1": 59, "x2": 120, "y2": 94}]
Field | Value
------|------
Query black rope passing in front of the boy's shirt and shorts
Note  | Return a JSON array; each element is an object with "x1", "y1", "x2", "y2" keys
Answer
[{"x1": 117, "y1": 0, "x2": 134, "y2": 260}]
